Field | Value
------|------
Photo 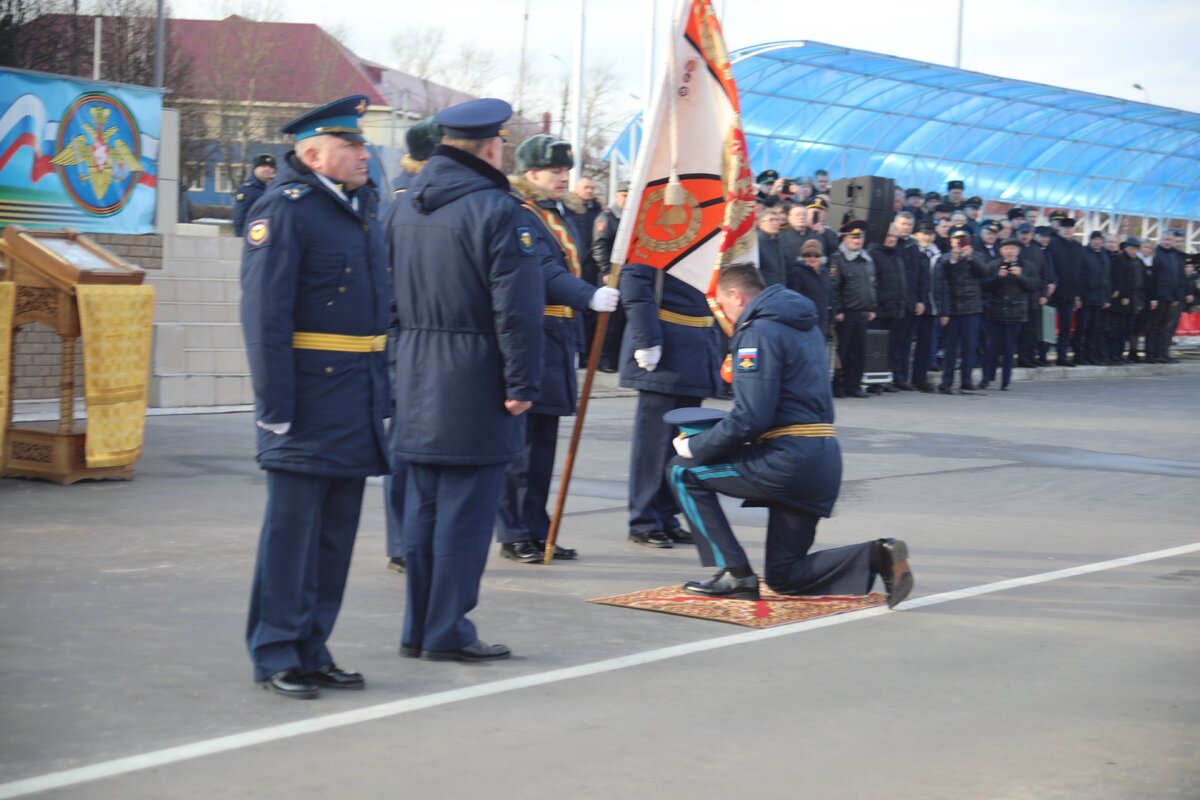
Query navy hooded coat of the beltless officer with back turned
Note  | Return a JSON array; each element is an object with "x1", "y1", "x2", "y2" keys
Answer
[{"x1": 386, "y1": 145, "x2": 546, "y2": 465}]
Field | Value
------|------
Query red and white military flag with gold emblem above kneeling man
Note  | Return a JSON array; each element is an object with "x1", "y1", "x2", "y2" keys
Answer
[{"x1": 612, "y1": 0, "x2": 757, "y2": 332}]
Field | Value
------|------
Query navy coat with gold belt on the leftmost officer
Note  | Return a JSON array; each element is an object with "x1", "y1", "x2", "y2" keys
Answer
[{"x1": 241, "y1": 152, "x2": 391, "y2": 477}]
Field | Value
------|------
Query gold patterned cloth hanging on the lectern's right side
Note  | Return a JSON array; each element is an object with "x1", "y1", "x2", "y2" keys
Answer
[{"x1": 76, "y1": 283, "x2": 155, "y2": 467}]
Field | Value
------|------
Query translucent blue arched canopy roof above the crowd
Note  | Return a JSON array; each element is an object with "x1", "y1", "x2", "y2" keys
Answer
[{"x1": 613, "y1": 42, "x2": 1200, "y2": 219}]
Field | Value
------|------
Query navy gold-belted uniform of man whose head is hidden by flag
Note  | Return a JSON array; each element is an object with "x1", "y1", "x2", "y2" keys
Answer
[{"x1": 619, "y1": 264, "x2": 721, "y2": 547}]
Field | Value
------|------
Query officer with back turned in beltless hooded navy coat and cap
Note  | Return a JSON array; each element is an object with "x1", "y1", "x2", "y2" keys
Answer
[{"x1": 386, "y1": 98, "x2": 546, "y2": 661}]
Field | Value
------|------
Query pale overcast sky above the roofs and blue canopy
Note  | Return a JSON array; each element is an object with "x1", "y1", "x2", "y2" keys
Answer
[{"x1": 172, "y1": 0, "x2": 1200, "y2": 119}]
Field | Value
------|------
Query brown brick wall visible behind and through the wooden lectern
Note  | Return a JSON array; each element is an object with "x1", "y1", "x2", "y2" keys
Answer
[{"x1": 12, "y1": 234, "x2": 162, "y2": 401}]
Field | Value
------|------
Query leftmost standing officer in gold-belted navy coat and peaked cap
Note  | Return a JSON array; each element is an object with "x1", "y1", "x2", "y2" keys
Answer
[{"x1": 241, "y1": 96, "x2": 391, "y2": 698}]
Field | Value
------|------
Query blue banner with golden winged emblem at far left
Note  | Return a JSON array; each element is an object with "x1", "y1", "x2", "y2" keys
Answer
[{"x1": 0, "y1": 68, "x2": 162, "y2": 234}]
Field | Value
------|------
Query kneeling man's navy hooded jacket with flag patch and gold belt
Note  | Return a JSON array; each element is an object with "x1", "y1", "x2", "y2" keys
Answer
[{"x1": 690, "y1": 285, "x2": 841, "y2": 517}]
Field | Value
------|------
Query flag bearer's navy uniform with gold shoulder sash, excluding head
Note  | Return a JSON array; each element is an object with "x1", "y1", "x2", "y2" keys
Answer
[{"x1": 496, "y1": 169, "x2": 596, "y2": 560}]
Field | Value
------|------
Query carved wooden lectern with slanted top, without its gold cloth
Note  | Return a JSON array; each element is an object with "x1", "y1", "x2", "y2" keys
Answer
[{"x1": 0, "y1": 225, "x2": 145, "y2": 483}]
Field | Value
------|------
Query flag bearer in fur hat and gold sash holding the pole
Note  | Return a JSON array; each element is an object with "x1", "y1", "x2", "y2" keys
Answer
[{"x1": 496, "y1": 133, "x2": 620, "y2": 564}]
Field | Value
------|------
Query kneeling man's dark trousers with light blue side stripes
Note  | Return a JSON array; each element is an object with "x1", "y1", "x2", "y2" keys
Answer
[{"x1": 667, "y1": 457, "x2": 875, "y2": 595}]
